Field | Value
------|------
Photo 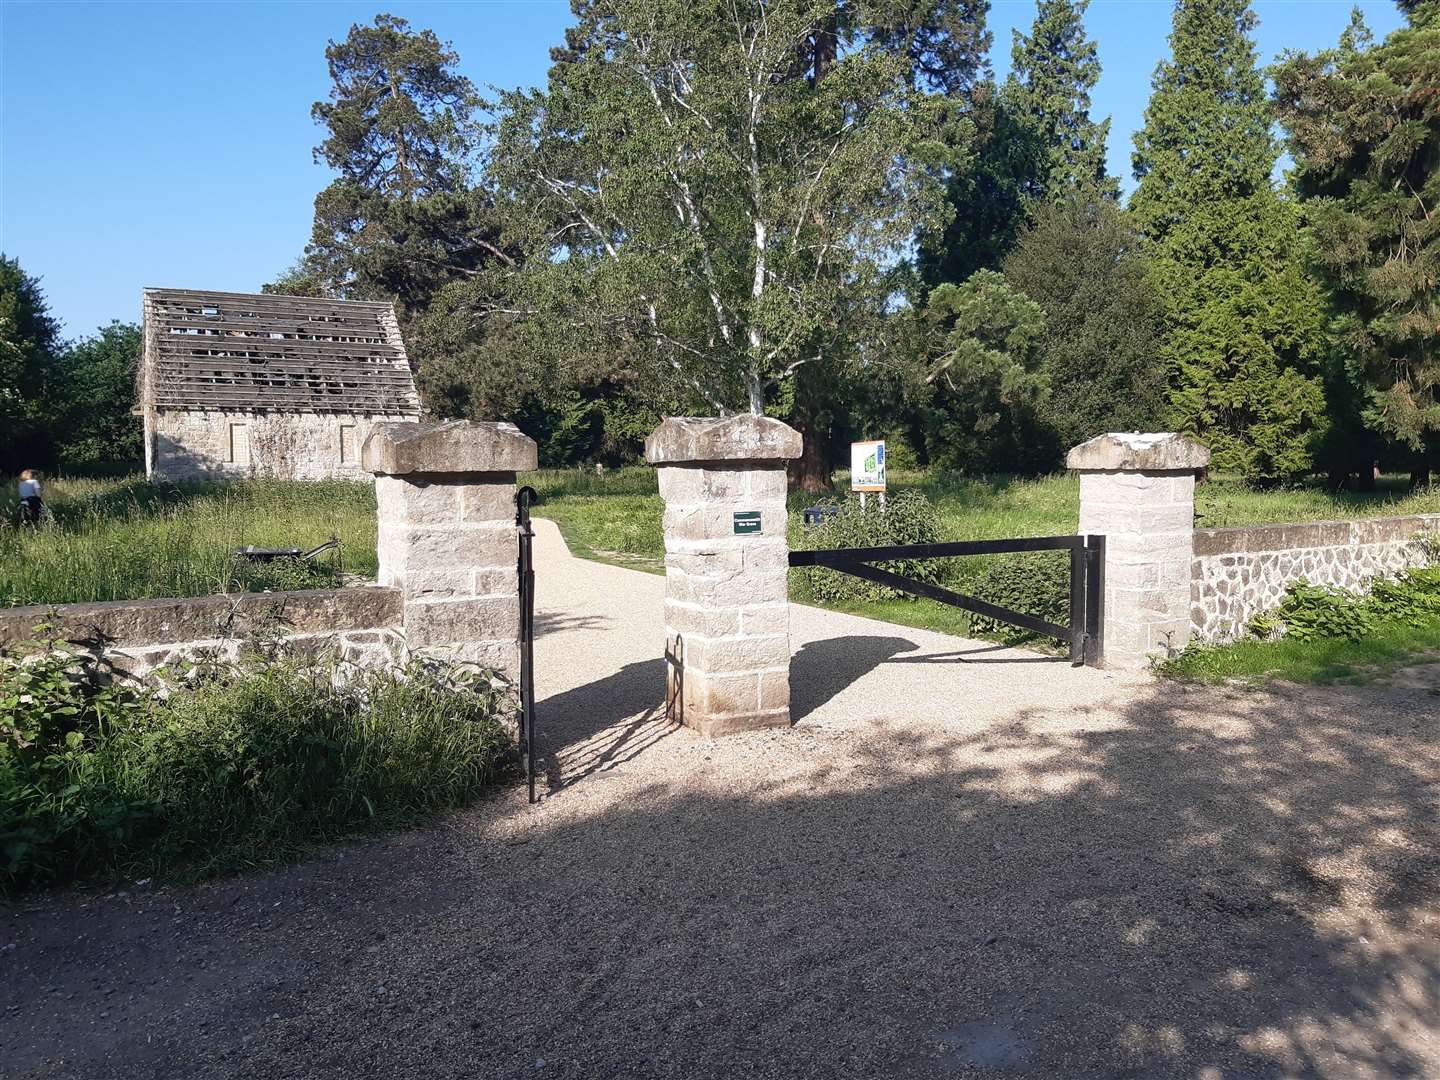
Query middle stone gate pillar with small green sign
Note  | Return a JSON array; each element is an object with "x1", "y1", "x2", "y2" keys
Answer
[{"x1": 645, "y1": 415, "x2": 801, "y2": 736}]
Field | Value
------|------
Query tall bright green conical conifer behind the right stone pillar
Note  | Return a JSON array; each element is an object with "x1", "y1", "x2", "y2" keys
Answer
[{"x1": 1130, "y1": 0, "x2": 1329, "y2": 478}]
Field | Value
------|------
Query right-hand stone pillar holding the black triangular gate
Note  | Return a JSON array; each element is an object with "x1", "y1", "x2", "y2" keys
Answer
[{"x1": 1066, "y1": 433, "x2": 1210, "y2": 670}]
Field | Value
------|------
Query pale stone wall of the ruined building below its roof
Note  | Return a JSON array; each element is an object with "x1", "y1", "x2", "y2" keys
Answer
[{"x1": 145, "y1": 409, "x2": 415, "y2": 481}]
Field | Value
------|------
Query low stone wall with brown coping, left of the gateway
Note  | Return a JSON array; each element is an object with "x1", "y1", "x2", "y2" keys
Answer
[{"x1": 0, "y1": 588, "x2": 405, "y2": 678}]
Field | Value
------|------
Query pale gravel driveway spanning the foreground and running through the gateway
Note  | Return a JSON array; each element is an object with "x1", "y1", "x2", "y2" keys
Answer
[{"x1": 0, "y1": 523, "x2": 1440, "y2": 1080}]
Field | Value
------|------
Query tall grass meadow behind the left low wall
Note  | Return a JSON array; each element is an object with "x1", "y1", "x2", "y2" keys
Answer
[{"x1": 0, "y1": 475, "x2": 376, "y2": 605}]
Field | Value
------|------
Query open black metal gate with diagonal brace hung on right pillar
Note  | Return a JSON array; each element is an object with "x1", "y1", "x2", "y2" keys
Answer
[{"x1": 791, "y1": 536, "x2": 1104, "y2": 667}]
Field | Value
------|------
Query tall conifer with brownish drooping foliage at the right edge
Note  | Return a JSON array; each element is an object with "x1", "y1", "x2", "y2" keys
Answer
[{"x1": 1276, "y1": 0, "x2": 1440, "y2": 480}]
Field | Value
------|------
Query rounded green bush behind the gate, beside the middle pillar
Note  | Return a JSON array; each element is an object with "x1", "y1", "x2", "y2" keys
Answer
[{"x1": 799, "y1": 491, "x2": 948, "y2": 605}]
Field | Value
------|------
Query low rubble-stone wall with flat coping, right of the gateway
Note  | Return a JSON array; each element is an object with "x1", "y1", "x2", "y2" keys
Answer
[{"x1": 1189, "y1": 514, "x2": 1440, "y2": 641}]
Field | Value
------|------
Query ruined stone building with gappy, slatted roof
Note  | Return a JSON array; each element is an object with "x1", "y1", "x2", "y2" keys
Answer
[{"x1": 138, "y1": 288, "x2": 420, "y2": 480}]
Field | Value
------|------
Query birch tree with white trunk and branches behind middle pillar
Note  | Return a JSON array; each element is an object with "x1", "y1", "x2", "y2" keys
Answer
[{"x1": 482, "y1": 0, "x2": 946, "y2": 413}]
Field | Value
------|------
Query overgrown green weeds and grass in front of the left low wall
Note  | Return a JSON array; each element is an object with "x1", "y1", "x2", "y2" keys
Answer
[{"x1": 0, "y1": 641, "x2": 513, "y2": 890}]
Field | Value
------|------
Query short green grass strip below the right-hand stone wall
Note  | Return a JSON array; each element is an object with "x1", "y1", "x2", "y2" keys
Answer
[{"x1": 1159, "y1": 621, "x2": 1440, "y2": 683}]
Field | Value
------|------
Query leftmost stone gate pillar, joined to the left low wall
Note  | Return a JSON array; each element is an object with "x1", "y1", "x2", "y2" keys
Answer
[{"x1": 360, "y1": 420, "x2": 536, "y2": 680}]
